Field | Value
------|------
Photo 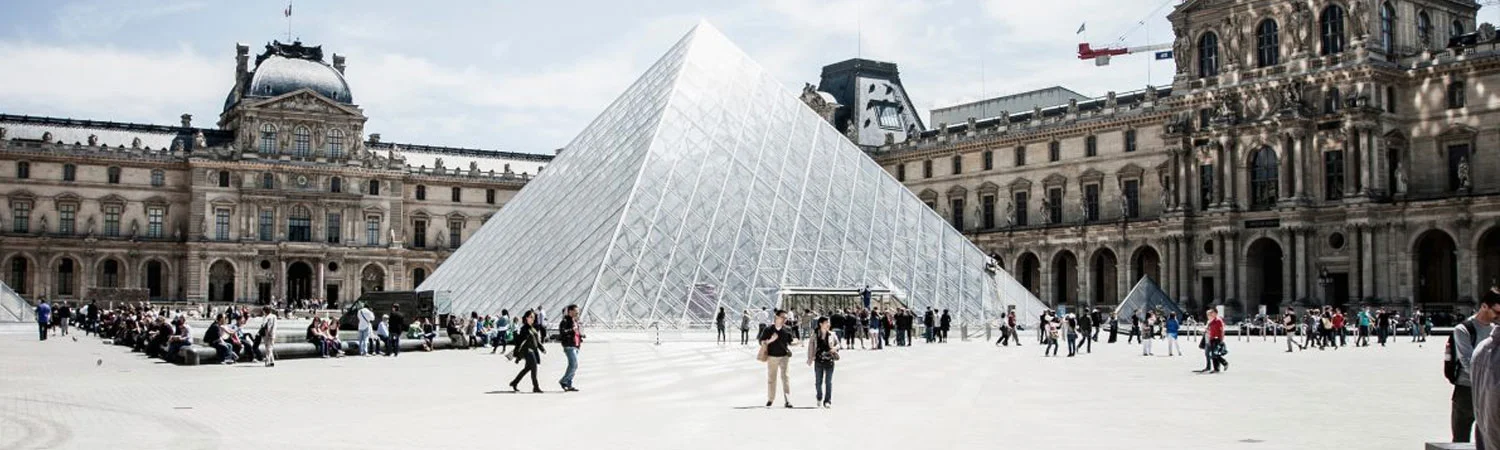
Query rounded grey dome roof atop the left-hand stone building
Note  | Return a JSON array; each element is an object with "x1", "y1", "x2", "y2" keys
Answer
[{"x1": 225, "y1": 42, "x2": 354, "y2": 108}]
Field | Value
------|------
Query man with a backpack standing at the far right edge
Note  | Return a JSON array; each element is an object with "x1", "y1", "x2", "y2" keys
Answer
[{"x1": 1443, "y1": 288, "x2": 1500, "y2": 443}]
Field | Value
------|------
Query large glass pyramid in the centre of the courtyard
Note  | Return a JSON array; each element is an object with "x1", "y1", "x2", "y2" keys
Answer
[{"x1": 419, "y1": 23, "x2": 1046, "y2": 329}]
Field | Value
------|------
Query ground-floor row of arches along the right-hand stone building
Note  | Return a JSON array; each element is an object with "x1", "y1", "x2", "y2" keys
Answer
[{"x1": 992, "y1": 221, "x2": 1500, "y2": 317}]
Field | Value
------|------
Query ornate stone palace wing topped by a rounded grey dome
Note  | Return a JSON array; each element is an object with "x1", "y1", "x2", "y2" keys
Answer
[{"x1": 0, "y1": 42, "x2": 551, "y2": 303}]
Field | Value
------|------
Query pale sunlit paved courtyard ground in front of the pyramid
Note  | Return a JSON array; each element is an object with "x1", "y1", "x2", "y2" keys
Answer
[{"x1": 0, "y1": 329, "x2": 1449, "y2": 450}]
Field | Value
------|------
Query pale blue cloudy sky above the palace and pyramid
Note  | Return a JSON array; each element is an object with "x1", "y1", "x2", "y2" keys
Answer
[{"x1": 0, "y1": 0, "x2": 1494, "y2": 153}]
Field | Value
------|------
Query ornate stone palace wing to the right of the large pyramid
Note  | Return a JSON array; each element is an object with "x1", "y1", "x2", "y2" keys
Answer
[{"x1": 852, "y1": 0, "x2": 1500, "y2": 317}]
